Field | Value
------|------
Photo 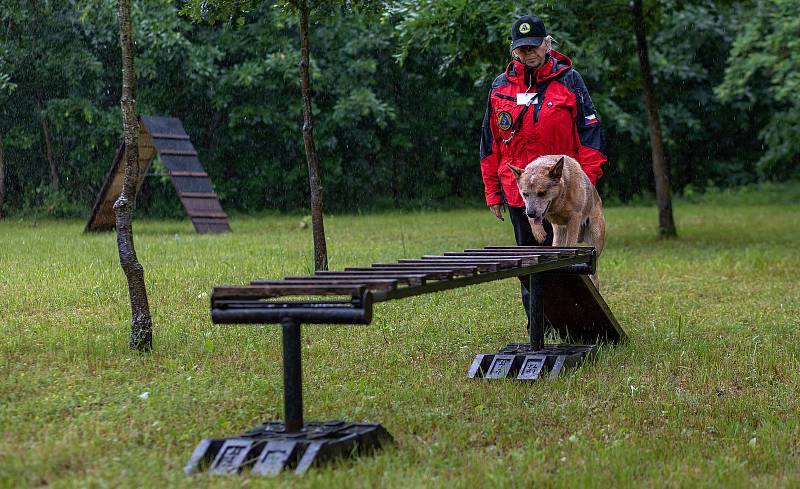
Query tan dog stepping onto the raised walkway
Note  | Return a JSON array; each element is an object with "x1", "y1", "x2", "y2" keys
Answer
[{"x1": 506, "y1": 155, "x2": 606, "y2": 290}]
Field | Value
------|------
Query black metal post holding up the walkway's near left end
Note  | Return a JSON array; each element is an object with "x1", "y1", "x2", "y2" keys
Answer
[{"x1": 281, "y1": 318, "x2": 303, "y2": 433}]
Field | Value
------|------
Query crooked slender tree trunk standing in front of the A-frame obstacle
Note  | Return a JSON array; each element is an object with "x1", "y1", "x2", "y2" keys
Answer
[{"x1": 114, "y1": 0, "x2": 153, "y2": 351}]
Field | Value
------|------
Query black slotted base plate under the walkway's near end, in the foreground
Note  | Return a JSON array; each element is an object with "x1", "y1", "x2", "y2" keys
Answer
[{"x1": 183, "y1": 421, "x2": 392, "y2": 475}]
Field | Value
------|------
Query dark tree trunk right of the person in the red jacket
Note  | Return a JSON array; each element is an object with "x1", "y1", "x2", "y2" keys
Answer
[{"x1": 631, "y1": 0, "x2": 678, "y2": 238}]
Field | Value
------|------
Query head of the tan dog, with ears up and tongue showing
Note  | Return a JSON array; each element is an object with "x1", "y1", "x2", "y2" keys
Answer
[{"x1": 506, "y1": 156, "x2": 564, "y2": 224}]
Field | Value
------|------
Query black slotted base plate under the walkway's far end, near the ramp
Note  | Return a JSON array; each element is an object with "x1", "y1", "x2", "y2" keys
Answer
[{"x1": 467, "y1": 343, "x2": 597, "y2": 380}]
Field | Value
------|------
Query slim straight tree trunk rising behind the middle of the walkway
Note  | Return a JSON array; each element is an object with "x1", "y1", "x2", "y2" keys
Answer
[{"x1": 300, "y1": 0, "x2": 328, "y2": 270}]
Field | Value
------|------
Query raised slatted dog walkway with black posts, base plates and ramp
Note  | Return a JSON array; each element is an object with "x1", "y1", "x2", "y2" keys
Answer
[{"x1": 184, "y1": 246, "x2": 626, "y2": 474}]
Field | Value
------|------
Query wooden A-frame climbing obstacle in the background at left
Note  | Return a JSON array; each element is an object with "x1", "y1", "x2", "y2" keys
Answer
[{"x1": 85, "y1": 116, "x2": 231, "y2": 233}]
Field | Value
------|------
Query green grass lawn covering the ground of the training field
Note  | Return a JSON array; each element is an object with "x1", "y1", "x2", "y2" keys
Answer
[{"x1": 0, "y1": 187, "x2": 800, "y2": 488}]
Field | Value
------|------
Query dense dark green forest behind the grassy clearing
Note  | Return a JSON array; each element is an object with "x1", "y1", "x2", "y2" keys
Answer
[{"x1": 0, "y1": 0, "x2": 800, "y2": 217}]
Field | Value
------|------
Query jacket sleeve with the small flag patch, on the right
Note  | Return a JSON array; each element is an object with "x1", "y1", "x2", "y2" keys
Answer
[{"x1": 574, "y1": 71, "x2": 608, "y2": 185}]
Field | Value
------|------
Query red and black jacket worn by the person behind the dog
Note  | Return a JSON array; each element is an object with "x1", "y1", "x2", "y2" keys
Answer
[{"x1": 481, "y1": 51, "x2": 606, "y2": 207}]
